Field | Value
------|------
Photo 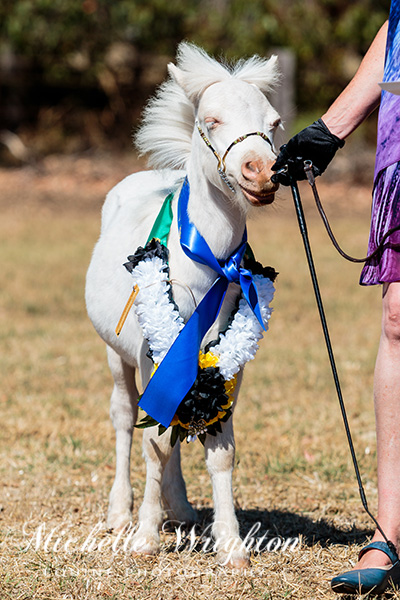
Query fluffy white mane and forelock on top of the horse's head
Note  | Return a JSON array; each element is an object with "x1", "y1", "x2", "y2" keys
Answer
[{"x1": 135, "y1": 42, "x2": 279, "y2": 169}]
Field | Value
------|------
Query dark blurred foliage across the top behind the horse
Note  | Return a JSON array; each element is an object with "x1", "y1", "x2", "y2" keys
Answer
[{"x1": 0, "y1": 0, "x2": 390, "y2": 155}]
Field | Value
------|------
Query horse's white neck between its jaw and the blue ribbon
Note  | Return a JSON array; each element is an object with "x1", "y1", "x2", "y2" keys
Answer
[{"x1": 188, "y1": 173, "x2": 246, "y2": 259}]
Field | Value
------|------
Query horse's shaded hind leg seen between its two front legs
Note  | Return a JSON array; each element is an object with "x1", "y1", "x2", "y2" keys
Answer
[{"x1": 161, "y1": 442, "x2": 197, "y2": 527}]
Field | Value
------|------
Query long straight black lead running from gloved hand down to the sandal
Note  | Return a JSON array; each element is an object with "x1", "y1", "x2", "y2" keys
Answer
[{"x1": 290, "y1": 171, "x2": 398, "y2": 558}]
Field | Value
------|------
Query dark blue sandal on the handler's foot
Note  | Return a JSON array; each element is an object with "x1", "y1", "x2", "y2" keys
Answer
[{"x1": 331, "y1": 542, "x2": 400, "y2": 595}]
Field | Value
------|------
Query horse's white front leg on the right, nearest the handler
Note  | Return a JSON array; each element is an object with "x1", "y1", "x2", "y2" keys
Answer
[{"x1": 205, "y1": 418, "x2": 249, "y2": 569}]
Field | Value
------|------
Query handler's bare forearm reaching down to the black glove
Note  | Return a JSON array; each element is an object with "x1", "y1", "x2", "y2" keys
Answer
[{"x1": 321, "y1": 21, "x2": 388, "y2": 140}]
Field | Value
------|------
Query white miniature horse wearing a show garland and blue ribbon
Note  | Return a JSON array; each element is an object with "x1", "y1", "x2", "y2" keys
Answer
[{"x1": 86, "y1": 43, "x2": 281, "y2": 567}]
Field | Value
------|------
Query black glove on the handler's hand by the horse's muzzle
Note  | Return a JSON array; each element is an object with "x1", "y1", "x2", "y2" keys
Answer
[{"x1": 272, "y1": 119, "x2": 344, "y2": 185}]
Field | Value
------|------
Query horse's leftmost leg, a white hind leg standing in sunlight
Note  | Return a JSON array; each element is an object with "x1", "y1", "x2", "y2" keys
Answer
[{"x1": 107, "y1": 347, "x2": 139, "y2": 531}]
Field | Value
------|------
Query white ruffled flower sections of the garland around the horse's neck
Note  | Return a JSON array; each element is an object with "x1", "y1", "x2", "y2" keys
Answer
[{"x1": 131, "y1": 257, "x2": 275, "y2": 381}]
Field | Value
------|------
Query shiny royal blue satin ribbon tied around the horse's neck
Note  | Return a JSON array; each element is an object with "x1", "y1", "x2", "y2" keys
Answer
[{"x1": 139, "y1": 178, "x2": 265, "y2": 427}]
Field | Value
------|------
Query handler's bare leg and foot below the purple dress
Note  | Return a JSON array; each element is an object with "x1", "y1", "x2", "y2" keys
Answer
[{"x1": 356, "y1": 282, "x2": 400, "y2": 568}]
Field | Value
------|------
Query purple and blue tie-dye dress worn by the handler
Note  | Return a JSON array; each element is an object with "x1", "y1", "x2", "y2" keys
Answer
[{"x1": 360, "y1": 0, "x2": 400, "y2": 285}]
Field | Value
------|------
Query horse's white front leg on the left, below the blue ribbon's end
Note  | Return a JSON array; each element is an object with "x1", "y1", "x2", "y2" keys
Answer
[{"x1": 132, "y1": 427, "x2": 173, "y2": 555}]
